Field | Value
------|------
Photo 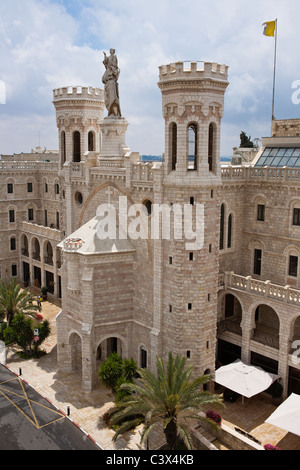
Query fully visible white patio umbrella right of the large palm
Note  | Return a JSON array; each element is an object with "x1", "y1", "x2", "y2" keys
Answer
[{"x1": 214, "y1": 360, "x2": 279, "y2": 398}]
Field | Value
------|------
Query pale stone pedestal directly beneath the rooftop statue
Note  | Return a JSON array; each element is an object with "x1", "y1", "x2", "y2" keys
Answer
[{"x1": 100, "y1": 117, "x2": 129, "y2": 159}]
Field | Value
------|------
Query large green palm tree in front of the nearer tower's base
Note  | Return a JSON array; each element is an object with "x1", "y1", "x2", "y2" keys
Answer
[{"x1": 110, "y1": 353, "x2": 223, "y2": 450}]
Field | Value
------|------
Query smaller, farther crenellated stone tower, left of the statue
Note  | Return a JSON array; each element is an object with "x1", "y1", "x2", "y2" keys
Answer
[{"x1": 53, "y1": 87, "x2": 104, "y2": 235}]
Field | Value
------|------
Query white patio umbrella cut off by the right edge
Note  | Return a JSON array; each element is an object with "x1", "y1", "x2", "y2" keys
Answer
[{"x1": 266, "y1": 393, "x2": 300, "y2": 436}]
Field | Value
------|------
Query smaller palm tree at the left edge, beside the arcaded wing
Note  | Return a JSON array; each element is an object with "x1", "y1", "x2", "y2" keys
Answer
[{"x1": 0, "y1": 279, "x2": 41, "y2": 325}]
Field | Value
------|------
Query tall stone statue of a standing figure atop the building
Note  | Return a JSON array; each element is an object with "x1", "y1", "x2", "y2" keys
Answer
[{"x1": 102, "y1": 49, "x2": 122, "y2": 118}]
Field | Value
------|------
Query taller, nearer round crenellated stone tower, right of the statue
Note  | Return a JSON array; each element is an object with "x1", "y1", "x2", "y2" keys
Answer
[{"x1": 154, "y1": 62, "x2": 229, "y2": 375}]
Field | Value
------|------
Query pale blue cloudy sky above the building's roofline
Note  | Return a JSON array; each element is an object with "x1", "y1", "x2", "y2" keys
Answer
[{"x1": 0, "y1": 0, "x2": 300, "y2": 156}]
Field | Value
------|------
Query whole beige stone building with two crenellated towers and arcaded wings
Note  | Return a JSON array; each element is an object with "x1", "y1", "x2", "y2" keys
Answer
[{"x1": 0, "y1": 58, "x2": 300, "y2": 395}]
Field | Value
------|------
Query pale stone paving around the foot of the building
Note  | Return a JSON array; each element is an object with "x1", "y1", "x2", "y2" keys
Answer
[{"x1": 2, "y1": 301, "x2": 300, "y2": 450}]
